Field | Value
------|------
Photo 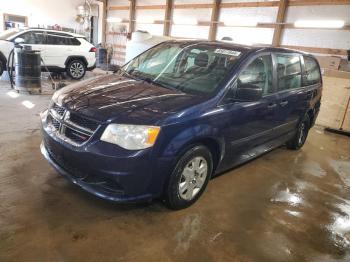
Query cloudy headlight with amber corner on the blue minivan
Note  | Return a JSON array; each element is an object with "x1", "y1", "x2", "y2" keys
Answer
[{"x1": 101, "y1": 124, "x2": 160, "y2": 150}]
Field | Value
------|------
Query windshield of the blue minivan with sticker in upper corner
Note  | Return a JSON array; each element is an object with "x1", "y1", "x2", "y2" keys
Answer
[{"x1": 122, "y1": 42, "x2": 241, "y2": 95}]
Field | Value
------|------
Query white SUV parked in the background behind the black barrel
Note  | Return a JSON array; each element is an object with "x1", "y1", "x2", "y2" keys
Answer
[{"x1": 0, "y1": 29, "x2": 96, "y2": 79}]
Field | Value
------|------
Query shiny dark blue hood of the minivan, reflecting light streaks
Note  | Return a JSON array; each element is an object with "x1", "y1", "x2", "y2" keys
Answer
[{"x1": 53, "y1": 74, "x2": 205, "y2": 124}]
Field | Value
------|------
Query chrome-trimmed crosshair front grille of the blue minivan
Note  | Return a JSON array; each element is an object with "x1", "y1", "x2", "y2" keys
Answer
[{"x1": 47, "y1": 104, "x2": 99, "y2": 146}]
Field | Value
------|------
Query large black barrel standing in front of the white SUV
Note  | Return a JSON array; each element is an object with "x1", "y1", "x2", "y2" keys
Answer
[{"x1": 15, "y1": 49, "x2": 41, "y2": 92}]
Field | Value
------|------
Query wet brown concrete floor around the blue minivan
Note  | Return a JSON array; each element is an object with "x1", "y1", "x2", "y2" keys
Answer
[{"x1": 0, "y1": 82, "x2": 350, "y2": 262}]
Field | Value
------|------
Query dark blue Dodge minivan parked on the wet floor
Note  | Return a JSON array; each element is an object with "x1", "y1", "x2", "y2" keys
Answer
[{"x1": 41, "y1": 41, "x2": 322, "y2": 209}]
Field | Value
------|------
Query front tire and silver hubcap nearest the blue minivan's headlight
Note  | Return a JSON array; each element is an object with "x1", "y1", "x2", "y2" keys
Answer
[{"x1": 165, "y1": 145, "x2": 213, "y2": 210}]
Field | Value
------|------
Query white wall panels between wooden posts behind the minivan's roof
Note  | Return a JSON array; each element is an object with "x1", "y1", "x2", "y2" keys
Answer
[{"x1": 109, "y1": 0, "x2": 350, "y2": 62}]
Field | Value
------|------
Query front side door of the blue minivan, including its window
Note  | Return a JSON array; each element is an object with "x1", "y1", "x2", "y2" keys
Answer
[{"x1": 221, "y1": 54, "x2": 279, "y2": 168}]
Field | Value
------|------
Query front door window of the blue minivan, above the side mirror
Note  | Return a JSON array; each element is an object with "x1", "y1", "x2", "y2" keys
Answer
[{"x1": 237, "y1": 55, "x2": 273, "y2": 94}]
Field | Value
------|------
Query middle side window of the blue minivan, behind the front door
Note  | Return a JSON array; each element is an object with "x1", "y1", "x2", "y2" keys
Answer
[{"x1": 276, "y1": 54, "x2": 301, "y2": 91}]
